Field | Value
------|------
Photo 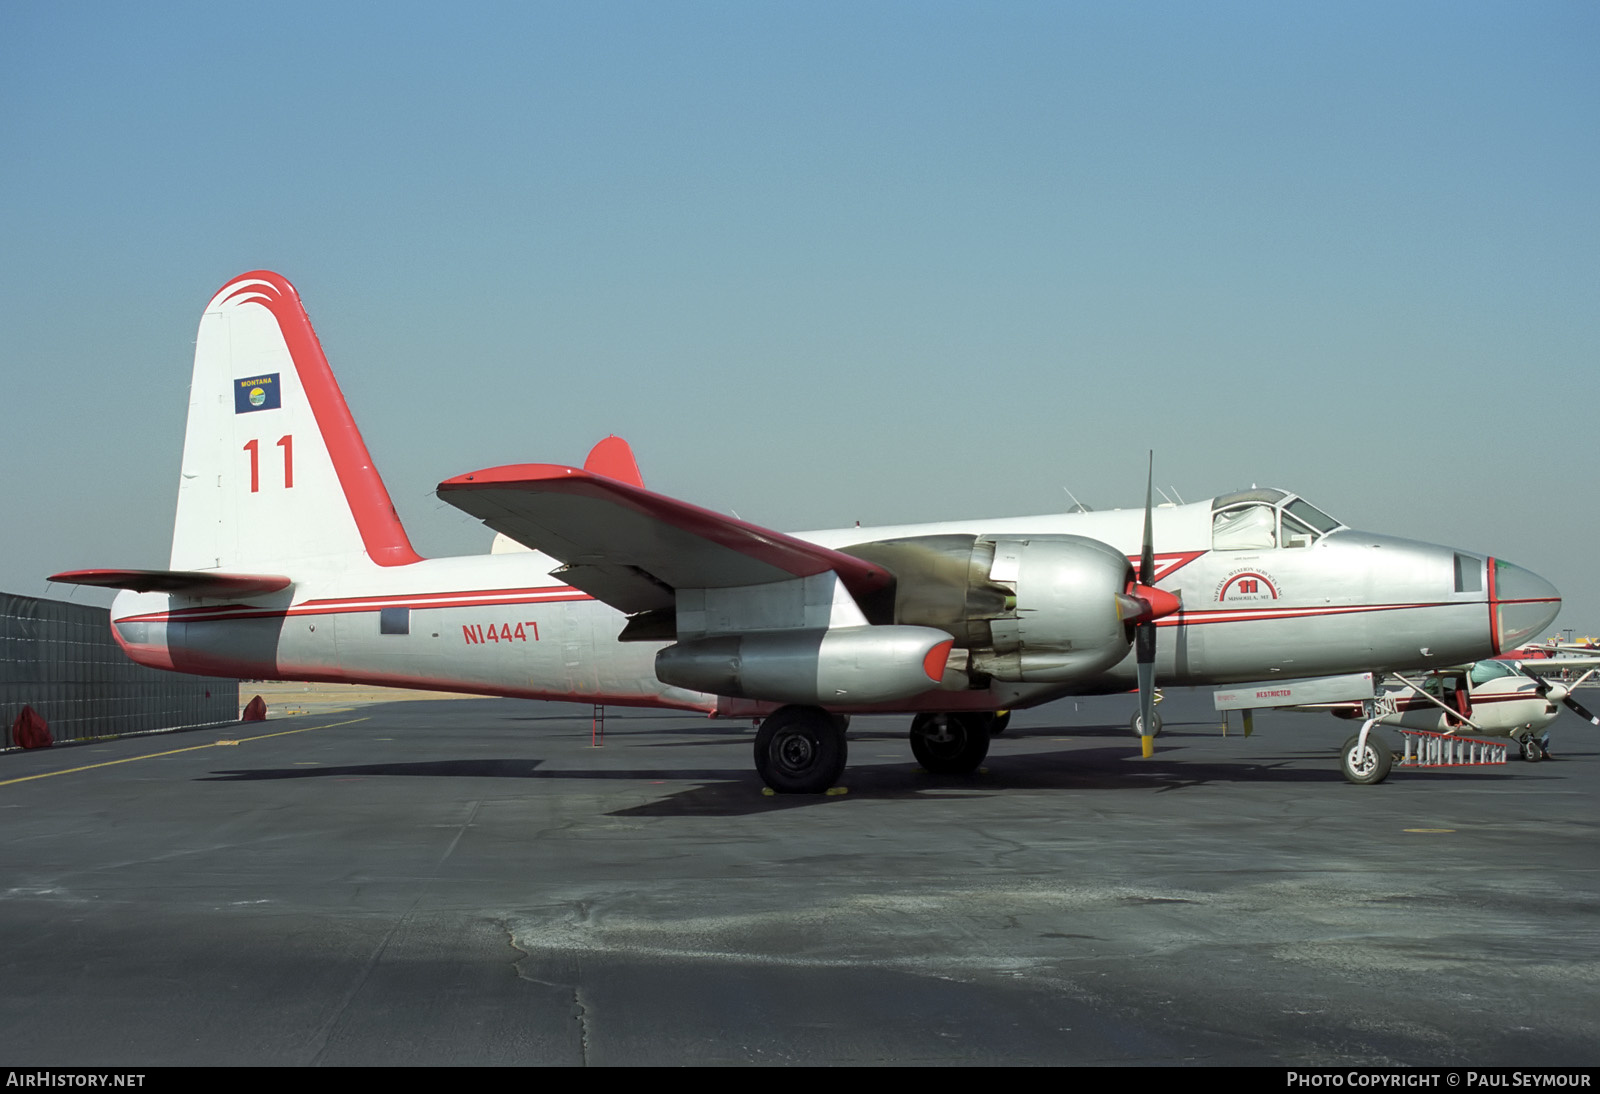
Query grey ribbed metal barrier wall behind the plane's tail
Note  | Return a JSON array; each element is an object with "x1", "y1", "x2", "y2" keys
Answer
[{"x1": 0, "y1": 593, "x2": 238, "y2": 749}]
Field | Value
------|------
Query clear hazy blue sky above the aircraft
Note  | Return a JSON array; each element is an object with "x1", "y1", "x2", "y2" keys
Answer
[{"x1": 0, "y1": 0, "x2": 1600, "y2": 633}]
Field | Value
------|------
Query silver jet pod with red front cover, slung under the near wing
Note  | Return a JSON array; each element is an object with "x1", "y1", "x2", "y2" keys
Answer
[{"x1": 656, "y1": 625, "x2": 955, "y2": 707}]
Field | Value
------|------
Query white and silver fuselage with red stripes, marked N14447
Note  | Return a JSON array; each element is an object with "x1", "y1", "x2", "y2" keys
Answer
[{"x1": 112, "y1": 501, "x2": 1539, "y2": 715}]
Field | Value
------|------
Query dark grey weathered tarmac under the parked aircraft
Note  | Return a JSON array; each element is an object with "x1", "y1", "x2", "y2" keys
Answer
[{"x1": 0, "y1": 691, "x2": 1600, "y2": 1067}]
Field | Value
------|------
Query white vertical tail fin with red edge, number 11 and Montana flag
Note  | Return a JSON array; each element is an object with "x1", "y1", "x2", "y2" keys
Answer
[{"x1": 171, "y1": 270, "x2": 419, "y2": 574}]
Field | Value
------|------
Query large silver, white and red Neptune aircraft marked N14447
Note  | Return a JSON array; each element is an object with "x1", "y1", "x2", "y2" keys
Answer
[{"x1": 54, "y1": 270, "x2": 1560, "y2": 793}]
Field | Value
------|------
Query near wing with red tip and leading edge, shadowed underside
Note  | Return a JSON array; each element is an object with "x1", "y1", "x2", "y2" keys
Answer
[{"x1": 438, "y1": 464, "x2": 893, "y2": 614}]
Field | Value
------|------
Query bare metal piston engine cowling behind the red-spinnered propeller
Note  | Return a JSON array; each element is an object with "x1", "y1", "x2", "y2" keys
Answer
[{"x1": 843, "y1": 536, "x2": 1133, "y2": 683}]
